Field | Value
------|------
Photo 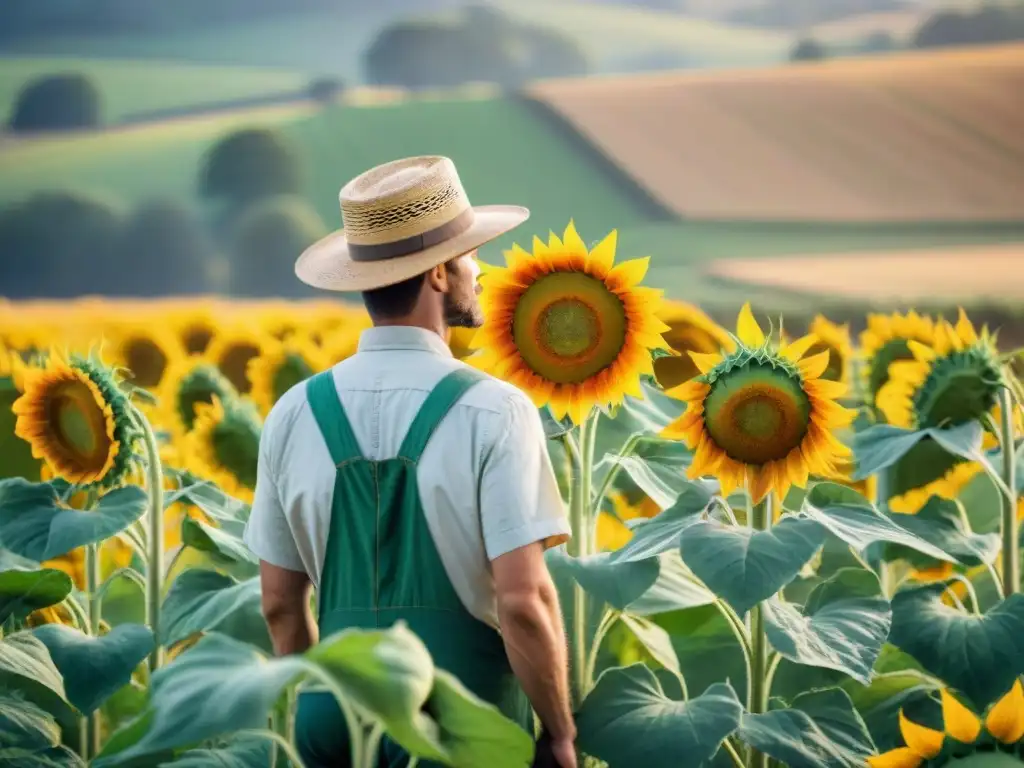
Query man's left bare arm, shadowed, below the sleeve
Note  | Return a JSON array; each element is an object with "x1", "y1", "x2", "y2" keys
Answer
[{"x1": 259, "y1": 560, "x2": 316, "y2": 656}]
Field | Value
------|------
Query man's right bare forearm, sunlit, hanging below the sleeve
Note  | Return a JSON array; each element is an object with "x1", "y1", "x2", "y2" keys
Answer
[{"x1": 492, "y1": 542, "x2": 575, "y2": 740}]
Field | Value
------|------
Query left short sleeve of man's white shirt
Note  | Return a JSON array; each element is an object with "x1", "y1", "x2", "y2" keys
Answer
[{"x1": 242, "y1": 414, "x2": 305, "y2": 572}]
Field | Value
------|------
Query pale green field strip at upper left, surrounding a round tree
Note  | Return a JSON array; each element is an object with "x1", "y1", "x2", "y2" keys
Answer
[{"x1": 0, "y1": 56, "x2": 310, "y2": 122}]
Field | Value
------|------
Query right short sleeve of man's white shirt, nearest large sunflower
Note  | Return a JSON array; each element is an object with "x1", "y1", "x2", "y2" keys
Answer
[{"x1": 480, "y1": 393, "x2": 571, "y2": 560}]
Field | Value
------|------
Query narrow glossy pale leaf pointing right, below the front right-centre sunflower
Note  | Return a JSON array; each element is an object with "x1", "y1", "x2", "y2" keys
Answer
[{"x1": 801, "y1": 482, "x2": 955, "y2": 561}]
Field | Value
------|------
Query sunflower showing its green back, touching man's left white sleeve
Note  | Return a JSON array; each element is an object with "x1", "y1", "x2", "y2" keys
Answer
[{"x1": 181, "y1": 397, "x2": 262, "y2": 503}]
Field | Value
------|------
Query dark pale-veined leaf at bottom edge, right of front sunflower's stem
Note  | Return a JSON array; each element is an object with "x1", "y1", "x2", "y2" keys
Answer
[{"x1": 739, "y1": 688, "x2": 874, "y2": 768}]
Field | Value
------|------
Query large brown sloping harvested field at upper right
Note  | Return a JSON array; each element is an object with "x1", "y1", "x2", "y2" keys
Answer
[{"x1": 531, "y1": 45, "x2": 1024, "y2": 221}]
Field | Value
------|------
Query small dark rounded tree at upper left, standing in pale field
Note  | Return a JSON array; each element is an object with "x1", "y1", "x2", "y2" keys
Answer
[{"x1": 10, "y1": 73, "x2": 100, "y2": 133}]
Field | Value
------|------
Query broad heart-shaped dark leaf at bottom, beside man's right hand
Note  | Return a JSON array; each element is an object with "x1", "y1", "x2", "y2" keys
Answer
[{"x1": 577, "y1": 664, "x2": 742, "y2": 768}]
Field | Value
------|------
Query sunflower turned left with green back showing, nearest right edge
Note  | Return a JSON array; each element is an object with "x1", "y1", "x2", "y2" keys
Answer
[{"x1": 877, "y1": 309, "x2": 1006, "y2": 429}]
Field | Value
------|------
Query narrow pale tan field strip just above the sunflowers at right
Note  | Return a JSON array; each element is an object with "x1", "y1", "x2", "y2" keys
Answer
[{"x1": 705, "y1": 243, "x2": 1024, "y2": 302}]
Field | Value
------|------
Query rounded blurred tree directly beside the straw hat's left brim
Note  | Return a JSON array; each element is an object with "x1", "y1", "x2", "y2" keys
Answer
[{"x1": 230, "y1": 196, "x2": 327, "y2": 297}]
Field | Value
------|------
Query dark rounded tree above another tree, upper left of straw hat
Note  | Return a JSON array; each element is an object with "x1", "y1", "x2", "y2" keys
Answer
[{"x1": 200, "y1": 128, "x2": 302, "y2": 208}]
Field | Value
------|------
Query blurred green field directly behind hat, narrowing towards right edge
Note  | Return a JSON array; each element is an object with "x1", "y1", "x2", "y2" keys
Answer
[{"x1": 6, "y1": 89, "x2": 1024, "y2": 313}]
